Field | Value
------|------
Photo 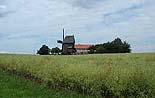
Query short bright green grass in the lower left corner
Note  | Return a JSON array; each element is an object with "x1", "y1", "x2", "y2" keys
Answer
[{"x1": 0, "y1": 69, "x2": 91, "y2": 98}]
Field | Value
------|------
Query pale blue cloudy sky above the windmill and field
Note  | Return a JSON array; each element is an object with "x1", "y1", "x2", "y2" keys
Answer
[{"x1": 0, "y1": 0, "x2": 155, "y2": 53}]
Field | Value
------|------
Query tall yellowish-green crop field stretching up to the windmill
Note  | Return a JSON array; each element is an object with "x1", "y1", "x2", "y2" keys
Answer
[{"x1": 0, "y1": 53, "x2": 155, "y2": 98}]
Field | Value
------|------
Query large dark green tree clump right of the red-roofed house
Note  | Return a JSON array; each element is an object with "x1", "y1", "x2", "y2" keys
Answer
[{"x1": 89, "y1": 38, "x2": 131, "y2": 53}]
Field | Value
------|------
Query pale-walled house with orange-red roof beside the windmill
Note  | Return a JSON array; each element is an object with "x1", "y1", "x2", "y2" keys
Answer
[{"x1": 74, "y1": 44, "x2": 92, "y2": 54}]
